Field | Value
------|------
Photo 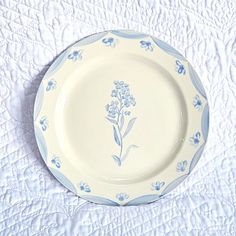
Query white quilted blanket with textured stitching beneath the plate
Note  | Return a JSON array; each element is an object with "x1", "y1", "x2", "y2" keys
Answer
[{"x1": 0, "y1": 0, "x2": 236, "y2": 236}]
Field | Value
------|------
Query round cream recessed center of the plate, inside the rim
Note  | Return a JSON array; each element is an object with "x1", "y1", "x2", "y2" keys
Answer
[{"x1": 55, "y1": 54, "x2": 187, "y2": 184}]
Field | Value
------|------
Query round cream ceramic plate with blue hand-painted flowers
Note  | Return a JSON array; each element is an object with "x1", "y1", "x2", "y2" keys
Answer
[{"x1": 34, "y1": 31, "x2": 209, "y2": 205}]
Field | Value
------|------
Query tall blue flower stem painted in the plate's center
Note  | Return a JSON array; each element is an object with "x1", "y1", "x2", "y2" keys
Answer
[{"x1": 106, "y1": 81, "x2": 137, "y2": 166}]
